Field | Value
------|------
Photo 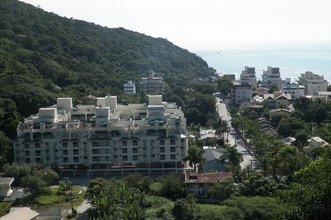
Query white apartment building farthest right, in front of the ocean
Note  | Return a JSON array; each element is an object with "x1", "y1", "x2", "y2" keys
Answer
[{"x1": 299, "y1": 71, "x2": 328, "y2": 95}]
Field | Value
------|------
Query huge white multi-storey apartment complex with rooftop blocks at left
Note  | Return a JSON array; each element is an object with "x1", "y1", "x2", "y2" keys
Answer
[{"x1": 14, "y1": 95, "x2": 188, "y2": 175}]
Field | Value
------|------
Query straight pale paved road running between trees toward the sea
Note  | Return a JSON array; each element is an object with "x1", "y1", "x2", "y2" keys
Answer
[{"x1": 216, "y1": 98, "x2": 255, "y2": 168}]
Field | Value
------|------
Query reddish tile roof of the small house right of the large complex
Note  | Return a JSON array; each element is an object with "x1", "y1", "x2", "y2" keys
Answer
[{"x1": 185, "y1": 172, "x2": 233, "y2": 183}]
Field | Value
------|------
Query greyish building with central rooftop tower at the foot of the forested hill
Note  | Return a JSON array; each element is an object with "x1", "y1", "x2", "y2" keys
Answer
[{"x1": 141, "y1": 70, "x2": 164, "y2": 94}]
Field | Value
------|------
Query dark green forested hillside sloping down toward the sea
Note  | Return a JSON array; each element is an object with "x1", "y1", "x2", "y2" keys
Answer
[{"x1": 0, "y1": 0, "x2": 213, "y2": 137}]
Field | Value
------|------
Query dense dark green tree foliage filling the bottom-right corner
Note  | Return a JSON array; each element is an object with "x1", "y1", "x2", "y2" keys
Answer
[{"x1": 276, "y1": 159, "x2": 331, "y2": 220}]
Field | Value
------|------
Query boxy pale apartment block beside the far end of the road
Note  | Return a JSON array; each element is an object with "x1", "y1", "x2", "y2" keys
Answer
[{"x1": 231, "y1": 81, "x2": 252, "y2": 105}]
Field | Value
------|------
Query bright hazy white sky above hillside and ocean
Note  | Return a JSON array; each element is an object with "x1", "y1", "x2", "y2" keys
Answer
[{"x1": 22, "y1": 0, "x2": 331, "y2": 51}]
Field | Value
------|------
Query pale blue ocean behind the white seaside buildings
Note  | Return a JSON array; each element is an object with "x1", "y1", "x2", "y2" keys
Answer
[{"x1": 194, "y1": 44, "x2": 331, "y2": 83}]
